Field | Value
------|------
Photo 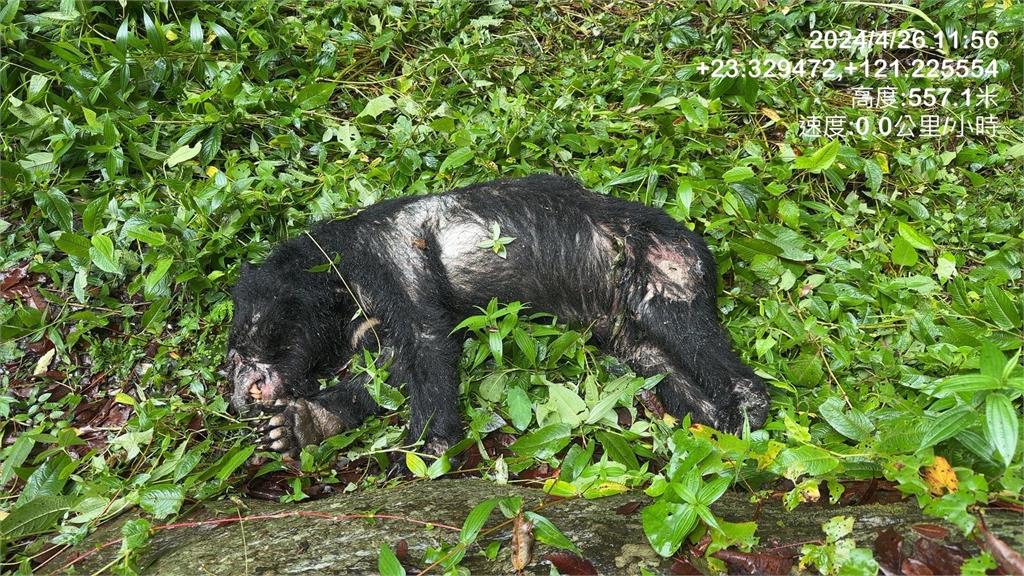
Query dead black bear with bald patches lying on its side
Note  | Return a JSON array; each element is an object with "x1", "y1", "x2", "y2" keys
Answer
[{"x1": 227, "y1": 175, "x2": 768, "y2": 456}]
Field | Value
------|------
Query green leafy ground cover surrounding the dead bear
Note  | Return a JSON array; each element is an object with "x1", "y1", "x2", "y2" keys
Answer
[{"x1": 0, "y1": 0, "x2": 1024, "y2": 574}]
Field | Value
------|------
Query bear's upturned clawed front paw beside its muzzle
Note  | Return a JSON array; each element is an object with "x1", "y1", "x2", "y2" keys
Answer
[{"x1": 257, "y1": 398, "x2": 345, "y2": 458}]
